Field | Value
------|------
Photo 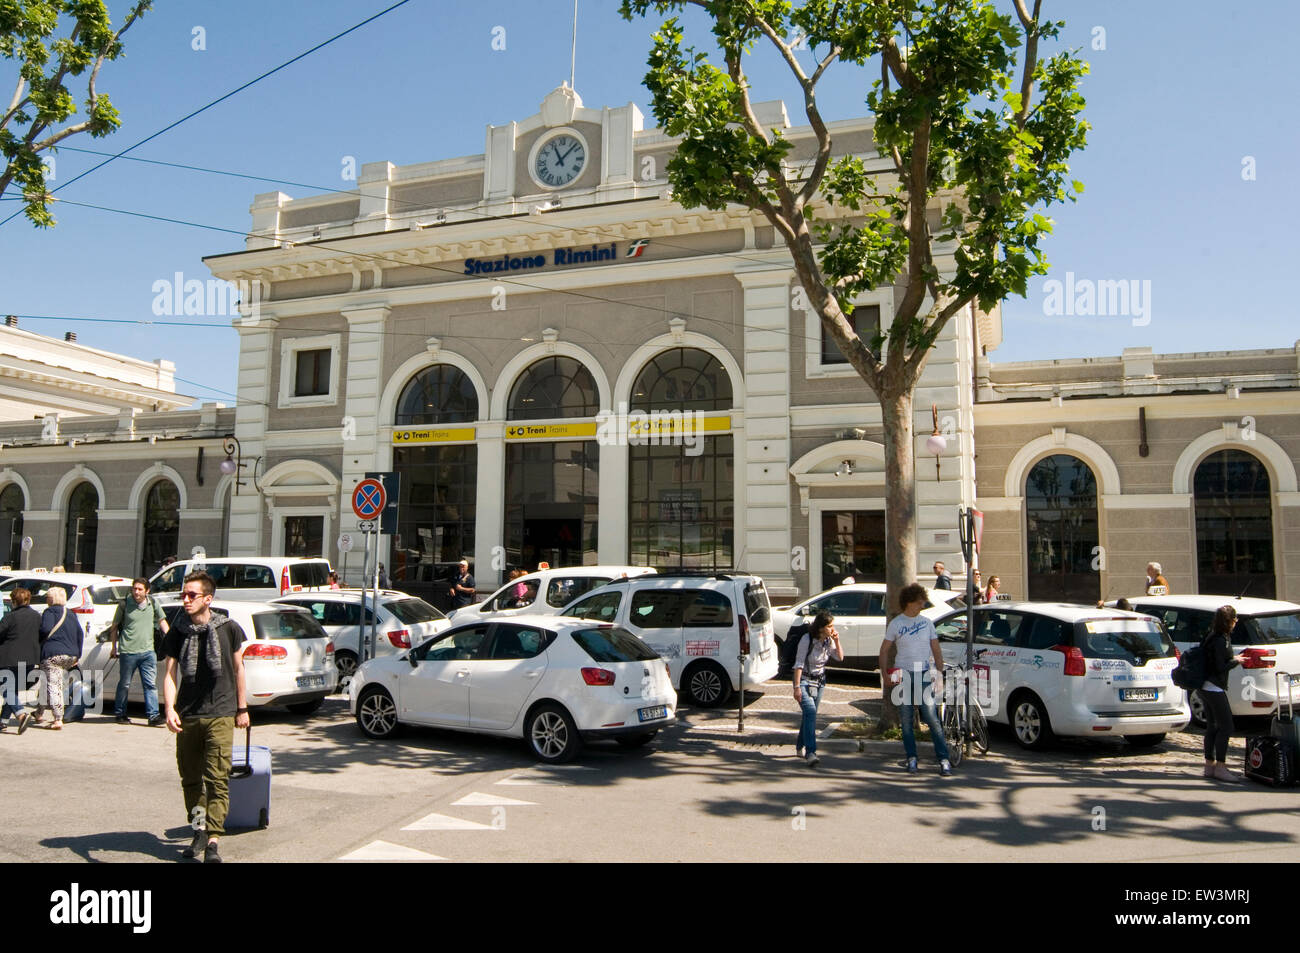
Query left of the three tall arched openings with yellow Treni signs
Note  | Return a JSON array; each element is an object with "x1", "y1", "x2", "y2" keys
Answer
[{"x1": 386, "y1": 364, "x2": 478, "y2": 608}]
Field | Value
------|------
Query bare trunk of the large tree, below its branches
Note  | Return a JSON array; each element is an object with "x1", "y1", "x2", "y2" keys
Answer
[{"x1": 880, "y1": 387, "x2": 917, "y2": 727}]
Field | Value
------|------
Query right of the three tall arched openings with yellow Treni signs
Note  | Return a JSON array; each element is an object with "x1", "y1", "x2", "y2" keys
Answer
[{"x1": 628, "y1": 347, "x2": 736, "y2": 569}]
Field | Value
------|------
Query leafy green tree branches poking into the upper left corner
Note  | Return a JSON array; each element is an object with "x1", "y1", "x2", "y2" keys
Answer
[{"x1": 0, "y1": 0, "x2": 153, "y2": 228}]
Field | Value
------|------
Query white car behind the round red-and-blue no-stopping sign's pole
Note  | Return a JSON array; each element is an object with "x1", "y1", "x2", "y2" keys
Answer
[{"x1": 272, "y1": 589, "x2": 451, "y2": 679}]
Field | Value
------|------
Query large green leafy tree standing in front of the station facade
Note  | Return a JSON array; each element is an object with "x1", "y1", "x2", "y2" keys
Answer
[{"x1": 621, "y1": 0, "x2": 1088, "y2": 631}]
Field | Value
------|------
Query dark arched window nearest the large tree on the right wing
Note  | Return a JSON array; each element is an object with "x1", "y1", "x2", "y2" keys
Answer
[{"x1": 1024, "y1": 454, "x2": 1101, "y2": 605}]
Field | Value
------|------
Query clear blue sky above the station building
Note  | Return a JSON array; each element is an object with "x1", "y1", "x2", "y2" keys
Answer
[{"x1": 0, "y1": 0, "x2": 1300, "y2": 403}]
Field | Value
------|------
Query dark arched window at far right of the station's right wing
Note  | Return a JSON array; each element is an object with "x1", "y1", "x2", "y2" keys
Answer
[{"x1": 1192, "y1": 450, "x2": 1277, "y2": 599}]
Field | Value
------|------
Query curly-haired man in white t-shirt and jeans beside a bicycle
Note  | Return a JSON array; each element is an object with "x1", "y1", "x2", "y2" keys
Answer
[{"x1": 880, "y1": 582, "x2": 953, "y2": 777}]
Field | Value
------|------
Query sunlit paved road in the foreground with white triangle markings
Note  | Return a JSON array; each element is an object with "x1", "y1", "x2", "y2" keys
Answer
[{"x1": 0, "y1": 676, "x2": 1300, "y2": 862}]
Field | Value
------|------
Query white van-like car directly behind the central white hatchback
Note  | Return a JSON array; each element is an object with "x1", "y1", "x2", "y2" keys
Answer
[{"x1": 563, "y1": 572, "x2": 777, "y2": 707}]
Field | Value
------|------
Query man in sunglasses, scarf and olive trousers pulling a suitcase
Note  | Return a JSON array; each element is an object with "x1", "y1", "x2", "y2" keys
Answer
[{"x1": 163, "y1": 572, "x2": 248, "y2": 863}]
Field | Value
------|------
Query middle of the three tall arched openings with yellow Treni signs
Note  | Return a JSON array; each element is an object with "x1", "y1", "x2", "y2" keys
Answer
[{"x1": 504, "y1": 356, "x2": 601, "y2": 569}]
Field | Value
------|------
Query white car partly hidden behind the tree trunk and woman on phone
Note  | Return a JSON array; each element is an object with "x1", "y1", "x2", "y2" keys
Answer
[{"x1": 772, "y1": 582, "x2": 965, "y2": 672}]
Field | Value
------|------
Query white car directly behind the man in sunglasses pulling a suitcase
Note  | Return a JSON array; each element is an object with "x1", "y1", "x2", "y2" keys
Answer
[{"x1": 81, "y1": 599, "x2": 338, "y2": 715}]
